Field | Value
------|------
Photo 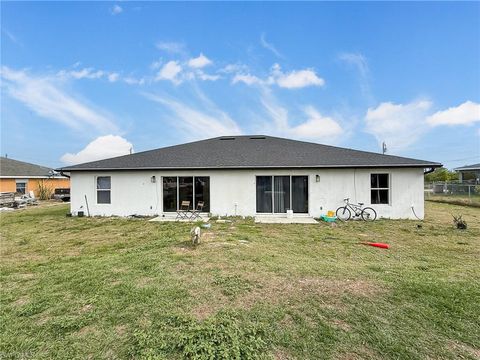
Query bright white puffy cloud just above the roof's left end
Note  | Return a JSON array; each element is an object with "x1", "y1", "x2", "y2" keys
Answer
[{"x1": 60, "y1": 135, "x2": 133, "y2": 165}]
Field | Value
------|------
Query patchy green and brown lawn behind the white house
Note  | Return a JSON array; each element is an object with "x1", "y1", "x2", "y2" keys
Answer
[{"x1": 0, "y1": 202, "x2": 480, "y2": 359}]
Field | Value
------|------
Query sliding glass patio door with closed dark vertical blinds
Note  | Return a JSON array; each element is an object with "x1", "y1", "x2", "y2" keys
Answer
[{"x1": 256, "y1": 175, "x2": 308, "y2": 214}]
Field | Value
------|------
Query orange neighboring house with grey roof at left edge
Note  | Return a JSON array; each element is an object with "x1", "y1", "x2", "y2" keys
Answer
[{"x1": 0, "y1": 157, "x2": 70, "y2": 196}]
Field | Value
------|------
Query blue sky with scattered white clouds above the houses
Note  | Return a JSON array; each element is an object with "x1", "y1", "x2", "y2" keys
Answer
[{"x1": 0, "y1": 1, "x2": 480, "y2": 168}]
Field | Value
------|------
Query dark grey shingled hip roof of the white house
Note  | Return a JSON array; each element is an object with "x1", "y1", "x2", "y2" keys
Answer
[{"x1": 60, "y1": 135, "x2": 441, "y2": 171}]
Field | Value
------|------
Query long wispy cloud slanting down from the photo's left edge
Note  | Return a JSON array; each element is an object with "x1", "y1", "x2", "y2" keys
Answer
[{"x1": 1, "y1": 66, "x2": 118, "y2": 132}]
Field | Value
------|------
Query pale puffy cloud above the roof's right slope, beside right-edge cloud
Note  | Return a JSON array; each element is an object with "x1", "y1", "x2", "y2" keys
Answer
[{"x1": 365, "y1": 100, "x2": 432, "y2": 149}]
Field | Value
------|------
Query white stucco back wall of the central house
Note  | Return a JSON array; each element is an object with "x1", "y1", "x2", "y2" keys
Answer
[{"x1": 71, "y1": 168, "x2": 424, "y2": 219}]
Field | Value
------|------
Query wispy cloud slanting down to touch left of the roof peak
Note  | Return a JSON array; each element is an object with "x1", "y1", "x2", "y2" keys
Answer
[{"x1": 145, "y1": 94, "x2": 242, "y2": 139}]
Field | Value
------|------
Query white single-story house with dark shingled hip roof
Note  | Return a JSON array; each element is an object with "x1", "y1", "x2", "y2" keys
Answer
[{"x1": 59, "y1": 135, "x2": 441, "y2": 218}]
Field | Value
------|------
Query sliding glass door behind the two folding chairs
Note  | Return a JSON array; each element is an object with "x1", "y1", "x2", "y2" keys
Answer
[{"x1": 163, "y1": 176, "x2": 210, "y2": 212}]
